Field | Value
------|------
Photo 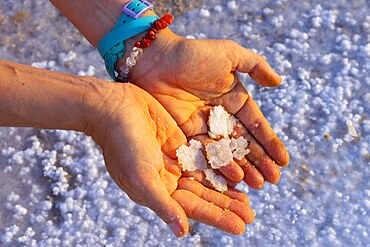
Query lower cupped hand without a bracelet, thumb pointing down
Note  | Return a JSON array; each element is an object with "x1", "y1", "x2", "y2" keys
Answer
[{"x1": 85, "y1": 83, "x2": 254, "y2": 237}]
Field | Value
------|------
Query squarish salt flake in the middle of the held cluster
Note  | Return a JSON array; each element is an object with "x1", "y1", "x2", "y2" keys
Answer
[{"x1": 206, "y1": 139, "x2": 233, "y2": 169}]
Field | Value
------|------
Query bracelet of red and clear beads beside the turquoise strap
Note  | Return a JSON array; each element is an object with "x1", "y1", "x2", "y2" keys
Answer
[{"x1": 118, "y1": 14, "x2": 173, "y2": 82}]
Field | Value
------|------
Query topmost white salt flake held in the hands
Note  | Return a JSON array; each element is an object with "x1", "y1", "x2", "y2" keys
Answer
[{"x1": 208, "y1": 106, "x2": 237, "y2": 138}]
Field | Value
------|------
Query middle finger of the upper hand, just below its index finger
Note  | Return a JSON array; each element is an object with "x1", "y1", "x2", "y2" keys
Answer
[{"x1": 234, "y1": 123, "x2": 281, "y2": 184}]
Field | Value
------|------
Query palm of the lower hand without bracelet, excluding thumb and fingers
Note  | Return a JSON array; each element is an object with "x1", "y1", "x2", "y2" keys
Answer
[{"x1": 92, "y1": 84, "x2": 186, "y2": 203}]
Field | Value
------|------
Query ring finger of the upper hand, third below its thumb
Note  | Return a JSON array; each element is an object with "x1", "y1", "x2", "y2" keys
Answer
[{"x1": 236, "y1": 157, "x2": 265, "y2": 190}]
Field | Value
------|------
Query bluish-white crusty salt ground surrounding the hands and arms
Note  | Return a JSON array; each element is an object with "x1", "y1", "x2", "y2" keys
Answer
[{"x1": 0, "y1": 0, "x2": 370, "y2": 246}]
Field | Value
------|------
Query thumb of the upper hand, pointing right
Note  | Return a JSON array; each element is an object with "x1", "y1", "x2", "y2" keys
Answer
[{"x1": 230, "y1": 42, "x2": 282, "y2": 87}]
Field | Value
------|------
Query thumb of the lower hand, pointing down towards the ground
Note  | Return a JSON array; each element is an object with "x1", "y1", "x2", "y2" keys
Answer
[{"x1": 146, "y1": 179, "x2": 189, "y2": 237}]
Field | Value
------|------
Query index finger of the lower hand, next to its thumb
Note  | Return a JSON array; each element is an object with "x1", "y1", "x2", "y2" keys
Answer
[{"x1": 172, "y1": 190, "x2": 245, "y2": 235}]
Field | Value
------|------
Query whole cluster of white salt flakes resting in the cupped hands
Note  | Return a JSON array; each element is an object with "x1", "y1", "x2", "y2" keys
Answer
[{"x1": 176, "y1": 106, "x2": 250, "y2": 192}]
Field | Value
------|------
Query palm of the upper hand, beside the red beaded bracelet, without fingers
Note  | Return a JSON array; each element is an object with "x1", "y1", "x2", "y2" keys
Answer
[{"x1": 132, "y1": 40, "x2": 248, "y2": 136}]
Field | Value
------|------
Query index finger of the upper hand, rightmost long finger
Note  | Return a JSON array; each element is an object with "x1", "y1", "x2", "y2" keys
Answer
[{"x1": 236, "y1": 97, "x2": 289, "y2": 166}]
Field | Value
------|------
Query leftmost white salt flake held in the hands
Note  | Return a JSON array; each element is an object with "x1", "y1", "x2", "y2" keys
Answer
[{"x1": 176, "y1": 140, "x2": 207, "y2": 171}]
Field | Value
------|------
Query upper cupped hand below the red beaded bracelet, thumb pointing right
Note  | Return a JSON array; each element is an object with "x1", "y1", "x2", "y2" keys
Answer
[{"x1": 118, "y1": 29, "x2": 289, "y2": 189}]
